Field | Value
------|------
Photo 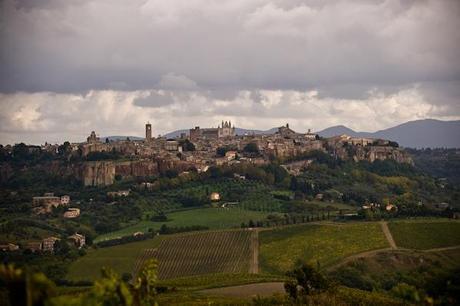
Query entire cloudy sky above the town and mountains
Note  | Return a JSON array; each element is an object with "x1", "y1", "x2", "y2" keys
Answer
[{"x1": 0, "y1": 0, "x2": 460, "y2": 144}]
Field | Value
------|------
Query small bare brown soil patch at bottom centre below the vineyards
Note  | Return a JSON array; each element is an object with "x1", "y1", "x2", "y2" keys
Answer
[{"x1": 199, "y1": 282, "x2": 284, "y2": 297}]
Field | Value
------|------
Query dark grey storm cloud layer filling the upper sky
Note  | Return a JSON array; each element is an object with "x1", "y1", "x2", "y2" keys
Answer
[{"x1": 0, "y1": 0, "x2": 460, "y2": 92}]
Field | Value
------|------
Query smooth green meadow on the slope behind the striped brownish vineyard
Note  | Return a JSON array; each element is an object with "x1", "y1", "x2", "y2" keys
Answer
[{"x1": 95, "y1": 208, "x2": 274, "y2": 242}]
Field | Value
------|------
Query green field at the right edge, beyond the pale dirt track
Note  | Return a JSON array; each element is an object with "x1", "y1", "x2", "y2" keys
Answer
[{"x1": 388, "y1": 220, "x2": 460, "y2": 250}]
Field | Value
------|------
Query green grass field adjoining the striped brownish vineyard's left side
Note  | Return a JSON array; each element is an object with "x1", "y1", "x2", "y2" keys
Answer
[{"x1": 67, "y1": 236, "x2": 163, "y2": 281}]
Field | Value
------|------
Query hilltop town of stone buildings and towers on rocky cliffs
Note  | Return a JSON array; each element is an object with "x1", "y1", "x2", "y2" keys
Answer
[{"x1": 3, "y1": 121, "x2": 412, "y2": 186}]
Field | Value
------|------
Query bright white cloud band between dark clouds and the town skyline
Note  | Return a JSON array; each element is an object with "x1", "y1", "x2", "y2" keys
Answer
[{"x1": 0, "y1": 86, "x2": 452, "y2": 143}]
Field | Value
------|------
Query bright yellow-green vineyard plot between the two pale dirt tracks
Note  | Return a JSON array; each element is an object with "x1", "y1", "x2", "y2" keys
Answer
[{"x1": 259, "y1": 223, "x2": 388, "y2": 273}]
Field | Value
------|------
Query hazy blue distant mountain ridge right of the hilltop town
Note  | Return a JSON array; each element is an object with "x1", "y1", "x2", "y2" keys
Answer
[{"x1": 318, "y1": 119, "x2": 460, "y2": 148}]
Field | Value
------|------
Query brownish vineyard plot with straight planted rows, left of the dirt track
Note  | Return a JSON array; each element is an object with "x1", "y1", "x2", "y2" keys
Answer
[{"x1": 136, "y1": 230, "x2": 252, "y2": 279}]
